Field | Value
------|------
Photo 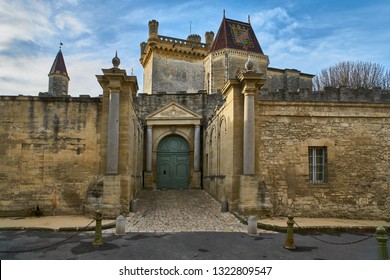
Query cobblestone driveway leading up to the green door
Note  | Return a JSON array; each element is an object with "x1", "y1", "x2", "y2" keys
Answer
[{"x1": 107, "y1": 190, "x2": 247, "y2": 232}]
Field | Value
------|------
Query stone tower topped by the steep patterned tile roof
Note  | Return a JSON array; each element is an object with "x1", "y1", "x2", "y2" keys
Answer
[{"x1": 204, "y1": 16, "x2": 269, "y2": 93}]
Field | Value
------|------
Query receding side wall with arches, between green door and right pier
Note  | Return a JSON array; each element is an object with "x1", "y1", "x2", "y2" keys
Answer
[{"x1": 203, "y1": 84, "x2": 244, "y2": 211}]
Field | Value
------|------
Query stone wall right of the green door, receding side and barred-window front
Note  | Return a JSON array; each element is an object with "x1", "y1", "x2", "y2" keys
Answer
[{"x1": 203, "y1": 84, "x2": 390, "y2": 219}]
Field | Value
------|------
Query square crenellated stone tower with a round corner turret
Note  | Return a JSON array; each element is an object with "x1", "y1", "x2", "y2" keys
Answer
[{"x1": 140, "y1": 20, "x2": 213, "y2": 94}]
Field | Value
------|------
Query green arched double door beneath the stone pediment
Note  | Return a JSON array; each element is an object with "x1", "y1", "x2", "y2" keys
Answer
[{"x1": 157, "y1": 135, "x2": 190, "y2": 189}]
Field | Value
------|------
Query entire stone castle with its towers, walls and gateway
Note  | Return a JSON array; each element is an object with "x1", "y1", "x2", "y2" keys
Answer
[{"x1": 0, "y1": 16, "x2": 390, "y2": 220}]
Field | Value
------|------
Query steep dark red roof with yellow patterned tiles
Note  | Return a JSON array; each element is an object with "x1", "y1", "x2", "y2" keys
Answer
[{"x1": 211, "y1": 17, "x2": 264, "y2": 54}]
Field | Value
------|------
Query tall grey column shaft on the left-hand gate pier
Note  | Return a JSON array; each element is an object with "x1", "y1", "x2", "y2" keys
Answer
[{"x1": 106, "y1": 92, "x2": 120, "y2": 174}]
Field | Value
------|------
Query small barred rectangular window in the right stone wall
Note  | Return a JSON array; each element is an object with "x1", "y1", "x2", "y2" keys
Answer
[{"x1": 309, "y1": 147, "x2": 327, "y2": 184}]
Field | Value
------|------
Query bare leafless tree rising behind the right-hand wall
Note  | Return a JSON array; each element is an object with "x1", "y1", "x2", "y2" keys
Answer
[{"x1": 313, "y1": 61, "x2": 390, "y2": 90}]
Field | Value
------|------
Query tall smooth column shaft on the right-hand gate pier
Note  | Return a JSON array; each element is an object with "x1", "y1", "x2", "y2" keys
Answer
[{"x1": 243, "y1": 91, "x2": 255, "y2": 175}]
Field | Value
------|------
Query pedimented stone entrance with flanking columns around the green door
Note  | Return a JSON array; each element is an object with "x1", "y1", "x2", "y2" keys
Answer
[{"x1": 144, "y1": 102, "x2": 202, "y2": 190}]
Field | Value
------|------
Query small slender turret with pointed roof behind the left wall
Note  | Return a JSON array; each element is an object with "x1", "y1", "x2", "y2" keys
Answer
[{"x1": 48, "y1": 49, "x2": 70, "y2": 96}]
